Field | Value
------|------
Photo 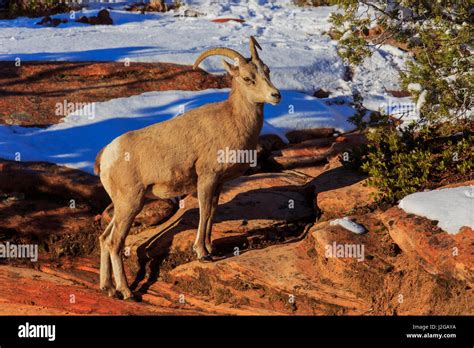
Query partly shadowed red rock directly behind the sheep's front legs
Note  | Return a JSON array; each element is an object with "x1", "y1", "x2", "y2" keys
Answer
[{"x1": 127, "y1": 173, "x2": 316, "y2": 278}]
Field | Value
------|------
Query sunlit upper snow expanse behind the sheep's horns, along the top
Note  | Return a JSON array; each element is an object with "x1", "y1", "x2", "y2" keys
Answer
[{"x1": 0, "y1": 0, "x2": 404, "y2": 102}]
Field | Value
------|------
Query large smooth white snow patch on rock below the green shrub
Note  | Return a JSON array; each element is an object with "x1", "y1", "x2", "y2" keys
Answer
[{"x1": 399, "y1": 185, "x2": 474, "y2": 234}]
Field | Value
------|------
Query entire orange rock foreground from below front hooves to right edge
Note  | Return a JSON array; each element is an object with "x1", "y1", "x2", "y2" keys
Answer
[{"x1": 143, "y1": 214, "x2": 474, "y2": 315}]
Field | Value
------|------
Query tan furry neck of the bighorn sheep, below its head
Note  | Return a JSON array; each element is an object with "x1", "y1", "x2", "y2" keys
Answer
[{"x1": 229, "y1": 84, "x2": 263, "y2": 147}]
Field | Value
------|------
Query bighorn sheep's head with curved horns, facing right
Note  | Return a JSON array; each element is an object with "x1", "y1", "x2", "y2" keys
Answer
[{"x1": 194, "y1": 36, "x2": 281, "y2": 105}]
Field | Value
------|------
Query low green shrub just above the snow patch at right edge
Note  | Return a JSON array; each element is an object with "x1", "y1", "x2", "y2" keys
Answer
[{"x1": 342, "y1": 118, "x2": 474, "y2": 203}]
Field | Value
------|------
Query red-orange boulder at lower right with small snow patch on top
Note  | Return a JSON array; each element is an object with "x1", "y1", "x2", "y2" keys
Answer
[{"x1": 310, "y1": 212, "x2": 474, "y2": 315}]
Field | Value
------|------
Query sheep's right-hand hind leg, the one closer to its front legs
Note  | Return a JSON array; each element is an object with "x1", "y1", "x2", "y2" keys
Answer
[{"x1": 106, "y1": 192, "x2": 144, "y2": 300}]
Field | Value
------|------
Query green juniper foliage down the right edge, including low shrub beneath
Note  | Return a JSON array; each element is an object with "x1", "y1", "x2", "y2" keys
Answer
[{"x1": 331, "y1": 0, "x2": 474, "y2": 202}]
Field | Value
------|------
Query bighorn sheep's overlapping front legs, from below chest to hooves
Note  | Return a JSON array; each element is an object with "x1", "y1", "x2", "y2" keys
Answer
[{"x1": 193, "y1": 178, "x2": 217, "y2": 261}]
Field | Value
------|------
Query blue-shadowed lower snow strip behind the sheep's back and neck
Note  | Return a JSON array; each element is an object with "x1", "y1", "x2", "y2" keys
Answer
[{"x1": 0, "y1": 89, "x2": 354, "y2": 173}]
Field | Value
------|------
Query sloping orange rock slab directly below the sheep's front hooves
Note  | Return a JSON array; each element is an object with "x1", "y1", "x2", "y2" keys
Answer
[{"x1": 165, "y1": 234, "x2": 369, "y2": 315}]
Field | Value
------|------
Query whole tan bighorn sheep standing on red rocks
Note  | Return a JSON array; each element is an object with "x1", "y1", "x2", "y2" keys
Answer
[{"x1": 95, "y1": 37, "x2": 281, "y2": 299}]
